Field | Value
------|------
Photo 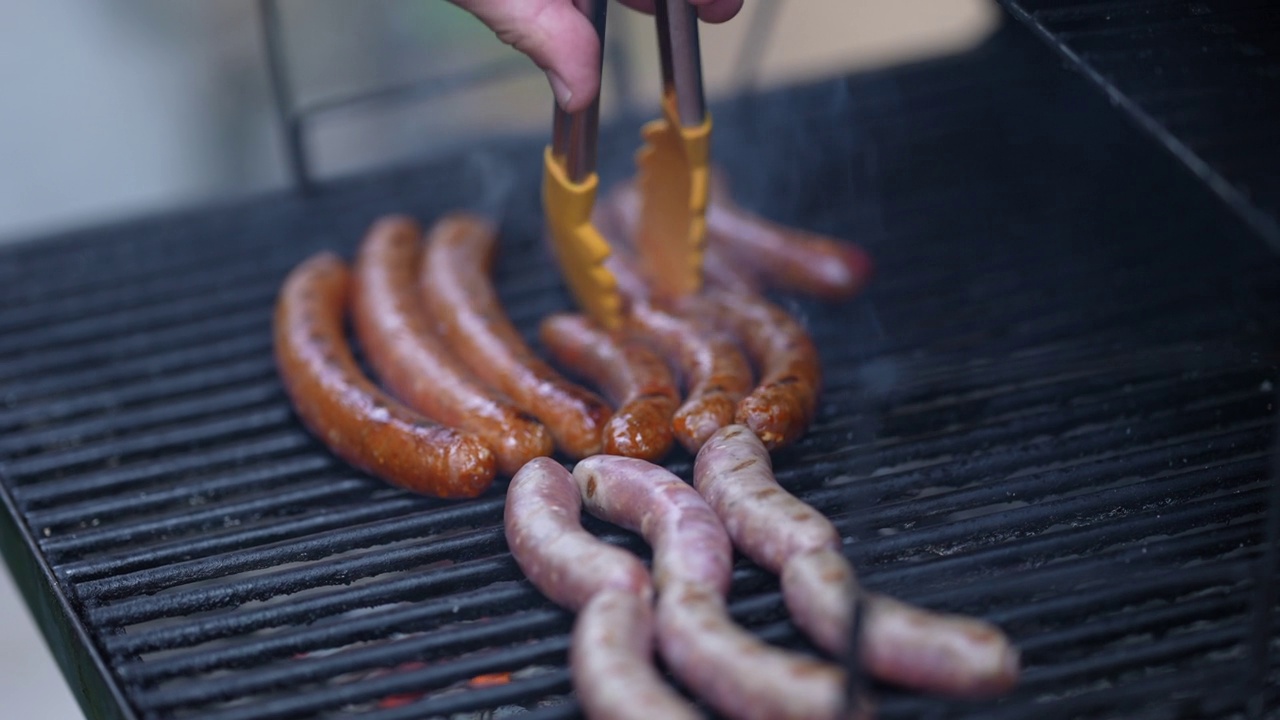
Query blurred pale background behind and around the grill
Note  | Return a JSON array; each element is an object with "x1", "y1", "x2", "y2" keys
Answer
[{"x1": 0, "y1": 0, "x2": 1000, "y2": 719}]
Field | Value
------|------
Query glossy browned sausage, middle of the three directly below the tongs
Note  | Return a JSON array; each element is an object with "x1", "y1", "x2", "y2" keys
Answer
[{"x1": 608, "y1": 250, "x2": 753, "y2": 452}]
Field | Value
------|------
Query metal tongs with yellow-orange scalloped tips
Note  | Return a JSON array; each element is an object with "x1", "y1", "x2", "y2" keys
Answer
[{"x1": 543, "y1": 0, "x2": 712, "y2": 329}]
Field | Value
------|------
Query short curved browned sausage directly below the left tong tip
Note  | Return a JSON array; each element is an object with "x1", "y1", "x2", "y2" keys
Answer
[{"x1": 540, "y1": 315, "x2": 680, "y2": 461}]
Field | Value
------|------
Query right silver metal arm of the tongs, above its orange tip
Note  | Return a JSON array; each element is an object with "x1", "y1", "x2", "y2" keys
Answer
[{"x1": 654, "y1": 0, "x2": 707, "y2": 127}]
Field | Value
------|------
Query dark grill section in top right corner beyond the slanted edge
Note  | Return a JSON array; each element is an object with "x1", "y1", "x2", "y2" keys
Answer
[{"x1": 1001, "y1": 0, "x2": 1280, "y2": 251}]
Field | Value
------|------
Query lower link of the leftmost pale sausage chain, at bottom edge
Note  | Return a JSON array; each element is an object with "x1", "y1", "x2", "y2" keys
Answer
[{"x1": 568, "y1": 589, "x2": 701, "y2": 720}]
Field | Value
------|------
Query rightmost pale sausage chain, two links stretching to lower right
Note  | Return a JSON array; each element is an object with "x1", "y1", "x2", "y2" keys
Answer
[{"x1": 694, "y1": 425, "x2": 1019, "y2": 696}]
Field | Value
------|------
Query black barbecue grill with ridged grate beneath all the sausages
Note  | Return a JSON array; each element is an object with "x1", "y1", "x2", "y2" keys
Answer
[{"x1": 0, "y1": 0, "x2": 1280, "y2": 720}]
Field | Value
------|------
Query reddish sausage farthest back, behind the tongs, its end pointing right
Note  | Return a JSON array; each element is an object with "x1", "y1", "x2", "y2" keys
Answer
[{"x1": 603, "y1": 179, "x2": 873, "y2": 301}]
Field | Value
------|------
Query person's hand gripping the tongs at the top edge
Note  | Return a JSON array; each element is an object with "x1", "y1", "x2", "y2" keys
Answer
[{"x1": 451, "y1": 0, "x2": 742, "y2": 113}]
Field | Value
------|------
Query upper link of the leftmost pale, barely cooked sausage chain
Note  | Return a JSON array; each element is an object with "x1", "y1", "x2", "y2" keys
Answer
[{"x1": 503, "y1": 457, "x2": 653, "y2": 610}]
